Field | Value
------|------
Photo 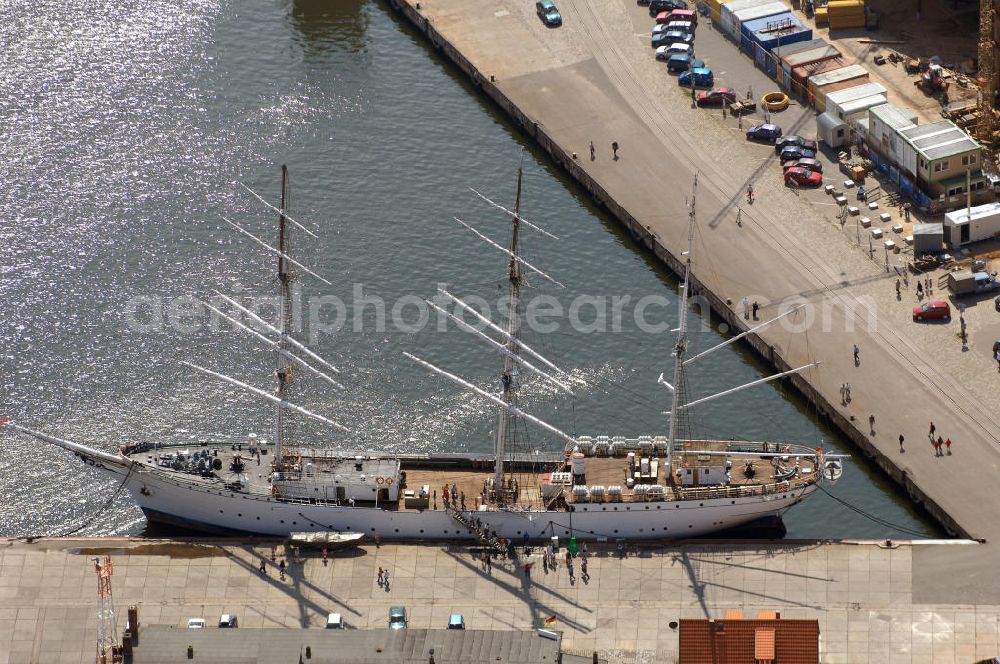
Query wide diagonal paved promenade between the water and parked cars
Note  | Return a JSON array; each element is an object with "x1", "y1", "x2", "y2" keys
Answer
[{"x1": 396, "y1": 0, "x2": 1000, "y2": 604}]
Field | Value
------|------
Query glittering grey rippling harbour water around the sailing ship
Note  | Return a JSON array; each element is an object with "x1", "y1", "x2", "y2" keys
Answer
[{"x1": 0, "y1": 0, "x2": 937, "y2": 537}]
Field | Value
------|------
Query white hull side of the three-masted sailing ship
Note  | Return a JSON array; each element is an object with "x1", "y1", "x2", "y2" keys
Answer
[{"x1": 90, "y1": 452, "x2": 816, "y2": 541}]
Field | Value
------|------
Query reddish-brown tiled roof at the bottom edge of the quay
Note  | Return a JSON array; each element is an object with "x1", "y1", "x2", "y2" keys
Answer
[{"x1": 678, "y1": 618, "x2": 819, "y2": 664}]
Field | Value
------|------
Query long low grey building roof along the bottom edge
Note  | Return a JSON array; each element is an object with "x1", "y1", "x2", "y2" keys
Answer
[{"x1": 132, "y1": 625, "x2": 561, "y2": 664}]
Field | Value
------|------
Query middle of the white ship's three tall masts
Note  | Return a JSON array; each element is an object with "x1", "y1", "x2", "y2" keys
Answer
[{"x1": 493, "y1": 167, "x2": 523, "y2": 501}]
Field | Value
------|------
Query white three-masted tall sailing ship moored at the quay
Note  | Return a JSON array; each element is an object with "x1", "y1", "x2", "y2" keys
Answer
[{"x1": 0, "y1": 167, "x2": 843, "y2": 545}]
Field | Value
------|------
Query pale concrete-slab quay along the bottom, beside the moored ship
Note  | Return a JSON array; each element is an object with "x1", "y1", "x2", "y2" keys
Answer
[{"x1": 0, "y1": 538, "x2": 988, "y2": 664}]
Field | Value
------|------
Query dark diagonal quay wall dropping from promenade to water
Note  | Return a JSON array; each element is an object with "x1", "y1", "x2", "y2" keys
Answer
[{"x1": 389, "y1": 0, "x2": 972, "y2": 539}]
